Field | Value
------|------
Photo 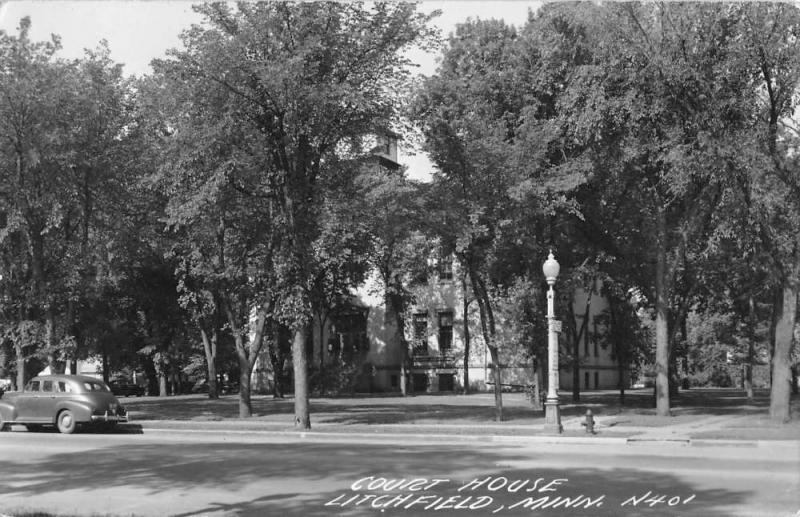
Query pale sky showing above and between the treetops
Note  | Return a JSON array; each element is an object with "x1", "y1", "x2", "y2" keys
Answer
[{"x1": 0, "y1": 0, "x2": 541, "y2": 179}]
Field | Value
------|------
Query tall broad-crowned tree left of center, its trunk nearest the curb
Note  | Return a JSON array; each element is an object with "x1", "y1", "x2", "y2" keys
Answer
[{"x1": 150, "y1": 2, "x2": 438, "y2": 428}]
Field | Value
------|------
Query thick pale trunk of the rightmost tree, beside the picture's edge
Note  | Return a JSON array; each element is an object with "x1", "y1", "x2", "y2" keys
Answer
[{"x1": 769, "y1": 282, "x2": 800, "y2": 422}]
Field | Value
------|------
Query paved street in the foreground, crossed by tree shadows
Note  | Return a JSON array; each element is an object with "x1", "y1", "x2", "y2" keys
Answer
[{"x1": 0, "y1": 432, "x2": 800, "y2": 517}]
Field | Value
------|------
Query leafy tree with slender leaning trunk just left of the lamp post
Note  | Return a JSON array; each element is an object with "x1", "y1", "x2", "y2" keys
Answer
[{"x1": 415, "y1": 12, "x2": 587, "y2": 418}]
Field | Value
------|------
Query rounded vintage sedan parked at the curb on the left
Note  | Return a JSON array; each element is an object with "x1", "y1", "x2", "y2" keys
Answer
[{"x1": 0, "y1": 375, "x2": 128, "y2": 434}]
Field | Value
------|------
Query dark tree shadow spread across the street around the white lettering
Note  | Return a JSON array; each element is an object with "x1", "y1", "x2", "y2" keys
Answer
[{"x1": 0, "y1": 443, "x2": 754, "y2": 517}]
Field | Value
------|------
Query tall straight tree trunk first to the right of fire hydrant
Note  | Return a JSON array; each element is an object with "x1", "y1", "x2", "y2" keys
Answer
[{"x1": 655, "y1": 208, "x2": 670, "y2": 416}]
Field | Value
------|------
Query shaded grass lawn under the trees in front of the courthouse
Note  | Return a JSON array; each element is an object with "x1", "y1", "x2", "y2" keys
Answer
[{"x1": 114, "y1": 389, "x2": 800, "y2": 440}]
